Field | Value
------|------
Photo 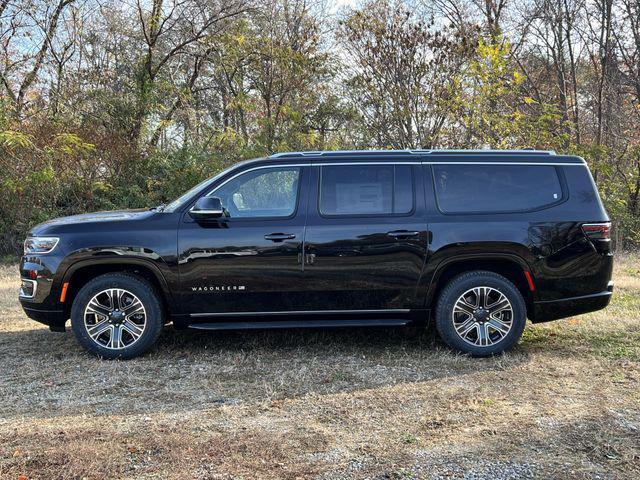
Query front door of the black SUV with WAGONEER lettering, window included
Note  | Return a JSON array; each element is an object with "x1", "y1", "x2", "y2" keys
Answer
[{"x1": 178, "y1": 166, "x2": 309, "y2": 317}]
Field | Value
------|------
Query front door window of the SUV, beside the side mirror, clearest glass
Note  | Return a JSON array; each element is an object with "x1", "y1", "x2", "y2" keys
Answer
[{"x1": 209, "y1": 167, "x2": 300, "y2": 218}]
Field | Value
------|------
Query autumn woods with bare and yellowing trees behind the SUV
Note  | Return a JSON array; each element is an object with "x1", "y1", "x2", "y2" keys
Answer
[{"x1": 0, "y1": 0, "x2": 640, "y2": 255}]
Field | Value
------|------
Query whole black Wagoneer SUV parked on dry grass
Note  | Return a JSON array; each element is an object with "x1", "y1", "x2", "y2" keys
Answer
[{"x1": 20, "y1": 150, "x2": 613, "y2": 358}]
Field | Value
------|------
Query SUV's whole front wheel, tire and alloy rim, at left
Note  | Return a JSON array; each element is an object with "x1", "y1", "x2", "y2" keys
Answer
[{"x1": 71, "y1": 273, "x2": 164, "y2": 358}]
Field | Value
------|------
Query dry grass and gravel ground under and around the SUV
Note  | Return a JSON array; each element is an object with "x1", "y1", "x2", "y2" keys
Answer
[{"x1": 0, "y1": 255, "x2": 640, "y2": 480}]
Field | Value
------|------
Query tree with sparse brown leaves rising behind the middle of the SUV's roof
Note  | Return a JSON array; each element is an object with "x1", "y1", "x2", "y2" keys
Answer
[{"x1": 338, "y1": 0, "x2": 472, "y2": 148}]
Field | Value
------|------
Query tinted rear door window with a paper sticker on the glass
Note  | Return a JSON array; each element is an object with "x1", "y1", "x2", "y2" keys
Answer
[{"x1": 320, "y1": 165, "x2": 413, "y2": 215}]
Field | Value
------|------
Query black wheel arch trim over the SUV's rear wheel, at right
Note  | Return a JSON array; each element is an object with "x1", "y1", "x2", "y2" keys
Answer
[{"x1": 426, "y1": 253, "x2": 535, "y2": 318}]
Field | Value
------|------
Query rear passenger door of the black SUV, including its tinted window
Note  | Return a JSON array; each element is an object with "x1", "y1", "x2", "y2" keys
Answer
[{"x1": 304, "y1": 161, "x2": 428, "y2": 311}]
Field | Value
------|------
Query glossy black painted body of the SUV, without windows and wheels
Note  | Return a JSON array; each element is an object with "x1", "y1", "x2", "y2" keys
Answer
[{"x1": 20, "y1": 151, "x2": 613, "y2": 330}]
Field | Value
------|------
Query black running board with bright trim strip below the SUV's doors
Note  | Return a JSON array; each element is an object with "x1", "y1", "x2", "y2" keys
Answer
[{"x1": 189, "y1": 318, "x2": 411, "y2": 330}]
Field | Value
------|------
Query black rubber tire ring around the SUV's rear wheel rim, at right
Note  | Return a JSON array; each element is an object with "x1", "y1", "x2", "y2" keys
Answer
[{"x1": 436, "y1": 271, "x2": 527, "y2": 357}]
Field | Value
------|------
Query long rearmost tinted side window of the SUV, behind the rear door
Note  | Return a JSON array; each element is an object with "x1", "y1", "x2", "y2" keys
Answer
[{"x1": 433, "y1": 164, "x2": 563, "y2": 213}]
